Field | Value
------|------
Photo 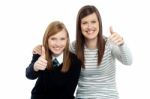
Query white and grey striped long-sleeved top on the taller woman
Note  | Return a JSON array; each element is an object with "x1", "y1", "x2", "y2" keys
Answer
[{"x1": 70, "y1": 40, "x2": 132, "y2": 99}]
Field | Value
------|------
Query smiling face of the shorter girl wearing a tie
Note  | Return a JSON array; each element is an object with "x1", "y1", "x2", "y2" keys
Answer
[{"x1": 48, "y1": 29, "x2": 68, "y2": 56}]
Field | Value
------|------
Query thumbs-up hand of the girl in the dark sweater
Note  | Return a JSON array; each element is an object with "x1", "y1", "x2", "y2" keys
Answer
[{"x1": 33, "y1": 46, "x2": 47, "y2": 71}]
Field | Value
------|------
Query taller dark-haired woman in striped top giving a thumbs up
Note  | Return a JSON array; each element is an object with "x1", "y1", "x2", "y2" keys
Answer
[{"x1": 33, "y1": 5, "x2": 132, "y2": 99}]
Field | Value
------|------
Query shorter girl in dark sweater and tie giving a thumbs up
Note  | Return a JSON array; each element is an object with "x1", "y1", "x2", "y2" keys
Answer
[{"x1": 26, "y1": 21, "x2": 81, "y2": 99}]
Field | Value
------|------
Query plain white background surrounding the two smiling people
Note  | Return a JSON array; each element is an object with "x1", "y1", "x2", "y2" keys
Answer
[{"x1": 0, "y1": 0, "x2": 150, "y2": 99}]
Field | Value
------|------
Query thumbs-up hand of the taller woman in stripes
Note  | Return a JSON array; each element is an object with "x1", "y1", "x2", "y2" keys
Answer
[{"x1": 108, "y1": 27, "x2": 124, "y2": 46}]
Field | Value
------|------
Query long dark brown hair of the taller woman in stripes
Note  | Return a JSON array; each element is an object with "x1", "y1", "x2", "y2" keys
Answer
[{"x1": 75, "y1": 5, "x2": 105, "y2": 68}]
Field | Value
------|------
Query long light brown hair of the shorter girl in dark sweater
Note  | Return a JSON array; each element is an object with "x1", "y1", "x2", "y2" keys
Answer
[{"x1": 43, "y1": 21, "x2": 71, "y2": 72}]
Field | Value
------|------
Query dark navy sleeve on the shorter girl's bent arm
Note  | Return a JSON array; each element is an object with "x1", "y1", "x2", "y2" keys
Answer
[{"x1": 26, "y1": 54, "x2": 39, "y2": 79}]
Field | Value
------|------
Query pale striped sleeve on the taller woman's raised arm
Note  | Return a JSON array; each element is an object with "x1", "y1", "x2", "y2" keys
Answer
[{"x1": 112, "y1": 43, "x2": 132, "y2": 65}]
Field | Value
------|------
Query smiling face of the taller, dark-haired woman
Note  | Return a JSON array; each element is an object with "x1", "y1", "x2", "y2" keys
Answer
[{"x1": 81, "y1": 13, "x2": 99, "y2": 40}]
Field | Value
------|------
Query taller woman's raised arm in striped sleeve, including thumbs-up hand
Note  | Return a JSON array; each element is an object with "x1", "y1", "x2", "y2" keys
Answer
[{"x1": 108, "y1": 27, "x2": 132, "y2": 65}]
